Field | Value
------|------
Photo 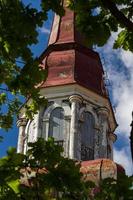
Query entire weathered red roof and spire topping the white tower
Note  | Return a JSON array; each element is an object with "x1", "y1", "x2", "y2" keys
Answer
[{"x1": 41, "y1": 0, "x2": 106, "y2": 96}]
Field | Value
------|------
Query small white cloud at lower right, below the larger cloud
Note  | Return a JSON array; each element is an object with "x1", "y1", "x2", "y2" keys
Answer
[{"x1": 114, "y1": 147, "x2": 133, "y2": 176}]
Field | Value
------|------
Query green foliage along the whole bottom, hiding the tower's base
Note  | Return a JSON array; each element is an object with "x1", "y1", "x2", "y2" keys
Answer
[{"x1": 0, "y1": 138, "x2": 133, "y2": 200}]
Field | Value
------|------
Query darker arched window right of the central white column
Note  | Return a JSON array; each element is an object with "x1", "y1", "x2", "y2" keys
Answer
[{"x1": 81, "y1": 112, "x2": 95, "y2": 160}]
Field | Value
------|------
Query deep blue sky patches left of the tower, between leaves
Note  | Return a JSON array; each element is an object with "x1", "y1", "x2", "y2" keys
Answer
[{"x1": 0, "y1": 0, "x2": 53, "y2": 157}]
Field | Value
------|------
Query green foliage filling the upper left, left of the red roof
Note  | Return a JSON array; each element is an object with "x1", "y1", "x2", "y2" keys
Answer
[{"x1": 0, "y1": 0, "x2": 47, "y2": 129}]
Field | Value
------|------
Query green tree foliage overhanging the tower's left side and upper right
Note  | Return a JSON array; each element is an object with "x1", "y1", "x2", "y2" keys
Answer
[{"x1": 0, "y1": 0, "x2": 133, "y2": 129}]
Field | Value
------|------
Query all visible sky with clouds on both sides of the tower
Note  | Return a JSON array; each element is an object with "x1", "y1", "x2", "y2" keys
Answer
[{"x1": 0, "y1": 0, "x2": 133, "y2": 174}]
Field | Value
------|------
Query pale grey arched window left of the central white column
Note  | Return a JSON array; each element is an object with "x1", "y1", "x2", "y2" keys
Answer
[{"x1": 48, "y1": 107, "x2": 65, "y2": 143}]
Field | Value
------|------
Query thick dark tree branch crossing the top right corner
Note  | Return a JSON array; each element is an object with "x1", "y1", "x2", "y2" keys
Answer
[{"x1": 101, "y1": 0, "x2": 133, "y2": 32}]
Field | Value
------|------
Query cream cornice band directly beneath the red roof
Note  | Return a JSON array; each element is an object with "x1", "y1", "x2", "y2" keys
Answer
[{"x1": 40, "y1": 83, "x2": 117, "y2": 132}]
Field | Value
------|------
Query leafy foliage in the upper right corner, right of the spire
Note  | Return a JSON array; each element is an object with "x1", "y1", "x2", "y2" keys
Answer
[{"x1": 69, "y1": 0, "x2": 133, "y2": 48}]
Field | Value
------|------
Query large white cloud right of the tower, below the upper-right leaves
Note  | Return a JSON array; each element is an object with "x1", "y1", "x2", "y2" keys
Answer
[{"x1": 110, "y1": 50, "x2": 133, "y2": 136}]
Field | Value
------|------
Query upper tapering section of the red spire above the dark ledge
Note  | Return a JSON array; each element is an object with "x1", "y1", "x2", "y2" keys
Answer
[{"x1": 48, "y1": 0, "x2": 83, "y2": 45}]
